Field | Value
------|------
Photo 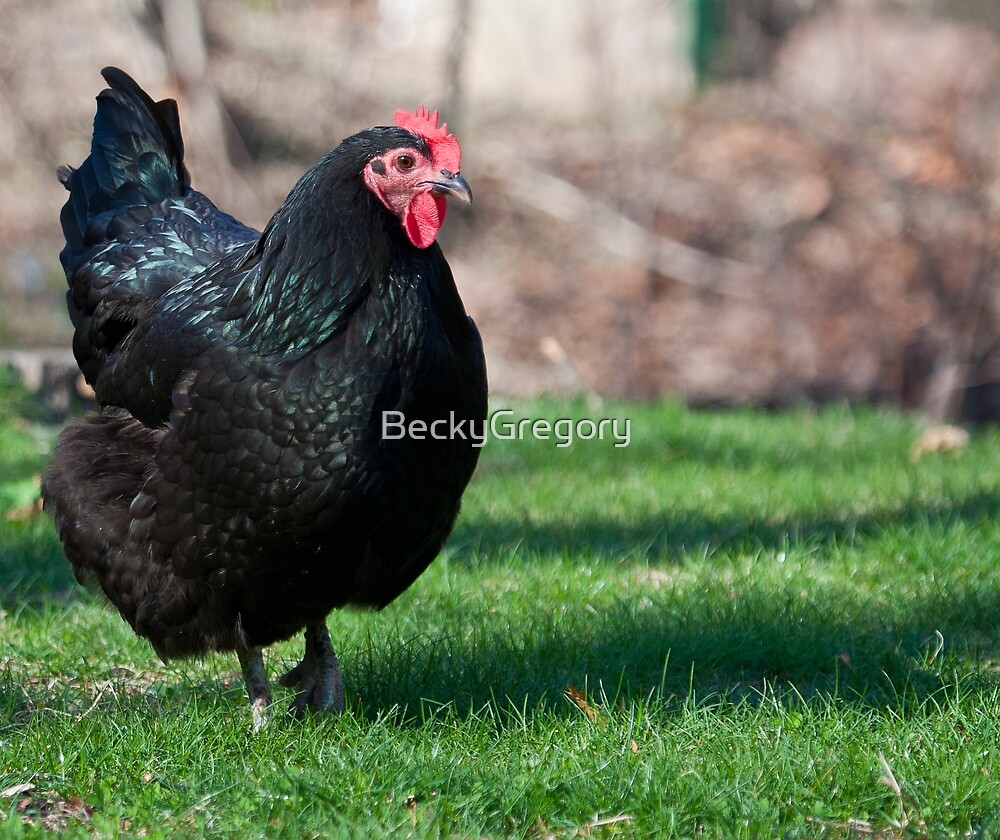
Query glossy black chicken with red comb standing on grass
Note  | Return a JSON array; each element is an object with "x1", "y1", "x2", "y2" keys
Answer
[{"x1": 43, "y1": 68, "x2": 486, "y2": 723}]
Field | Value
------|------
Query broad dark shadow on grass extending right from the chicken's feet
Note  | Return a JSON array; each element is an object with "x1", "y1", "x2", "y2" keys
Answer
[{"x1": 342, "y1": 580, "x2": 1000, "y2": 723}]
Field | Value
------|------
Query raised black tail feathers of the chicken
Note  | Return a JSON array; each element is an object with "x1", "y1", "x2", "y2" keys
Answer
[{"x1": 58, "y1": 67, "x2": 189, "y2": 267}]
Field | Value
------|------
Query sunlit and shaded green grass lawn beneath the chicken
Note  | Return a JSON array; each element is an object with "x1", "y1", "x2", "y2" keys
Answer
[{"x1": 0, "y1": 402, "x2": 1000, "y2": 838}]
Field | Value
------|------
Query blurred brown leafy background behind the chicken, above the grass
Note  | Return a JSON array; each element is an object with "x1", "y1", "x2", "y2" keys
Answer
[{"x1": 0, "y1": 0, "x2": 1000, "y2": 421}]
